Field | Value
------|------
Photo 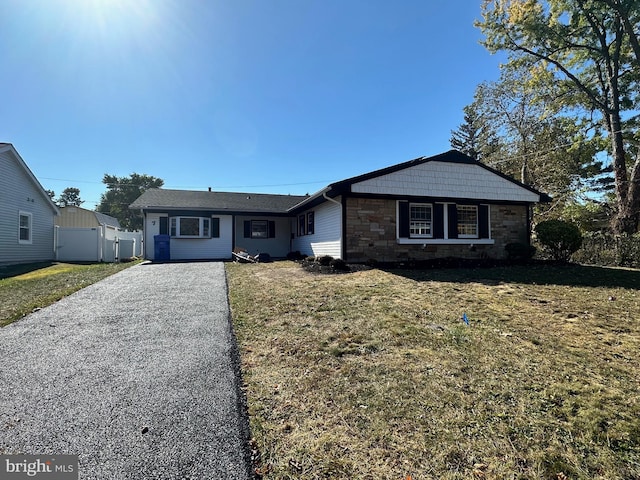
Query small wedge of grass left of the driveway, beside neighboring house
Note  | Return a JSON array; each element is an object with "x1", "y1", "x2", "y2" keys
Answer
[{"x1": 0, "y1": 262, "x2": 138, "y2": 327}]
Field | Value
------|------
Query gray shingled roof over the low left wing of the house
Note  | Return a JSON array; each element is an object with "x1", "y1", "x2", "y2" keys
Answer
[{"x1": 129, "y1": 188, "x2": 307, "y2": 213}]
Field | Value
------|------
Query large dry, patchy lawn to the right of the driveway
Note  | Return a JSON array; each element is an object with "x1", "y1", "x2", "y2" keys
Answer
[{"x1": 227, "y1": 262, "x2": 640, "y2": 480}]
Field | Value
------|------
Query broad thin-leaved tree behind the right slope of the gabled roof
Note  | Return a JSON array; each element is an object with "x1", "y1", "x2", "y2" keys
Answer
[{"x1": 464, "y1": 66, "x2": 608, "y2": 216}]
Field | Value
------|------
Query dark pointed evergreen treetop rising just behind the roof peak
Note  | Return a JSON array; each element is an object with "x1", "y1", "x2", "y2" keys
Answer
[{"x1": 449, "y1": 104, "x2": 496, "y2": 160}]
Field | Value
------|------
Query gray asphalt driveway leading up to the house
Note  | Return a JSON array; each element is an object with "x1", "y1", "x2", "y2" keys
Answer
[{"x1": 0, "y1": 263, "x2": 250, "y2": 480}]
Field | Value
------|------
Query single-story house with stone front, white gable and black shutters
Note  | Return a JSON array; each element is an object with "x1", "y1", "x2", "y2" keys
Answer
[{"x1": 130, "y1": 150, "x2": 549, "y2": 263}]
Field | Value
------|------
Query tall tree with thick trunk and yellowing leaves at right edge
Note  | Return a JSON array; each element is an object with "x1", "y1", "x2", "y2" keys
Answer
[{"x1": 477, "y1": 0, "x2": 640, "y2": 233}]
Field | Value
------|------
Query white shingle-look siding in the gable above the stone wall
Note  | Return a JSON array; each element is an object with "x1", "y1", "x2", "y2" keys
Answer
[{"x1": 351, "y1": 161, "x2": 540, "y2": 202}]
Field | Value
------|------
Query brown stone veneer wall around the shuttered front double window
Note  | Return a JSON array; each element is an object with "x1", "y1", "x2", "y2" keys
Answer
[{"x1": 345, "y1": 198, "x2": 529, "y2": 263}]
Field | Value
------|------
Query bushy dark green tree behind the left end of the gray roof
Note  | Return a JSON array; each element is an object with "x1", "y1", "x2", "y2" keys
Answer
[{"x1": 96, "y1": 173, "x2": 164, "y2": 231}]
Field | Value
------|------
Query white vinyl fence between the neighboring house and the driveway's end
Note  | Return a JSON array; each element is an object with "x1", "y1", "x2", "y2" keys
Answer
[{"x1": 55, "y1": 226, "x2": 142, "y2": 262}]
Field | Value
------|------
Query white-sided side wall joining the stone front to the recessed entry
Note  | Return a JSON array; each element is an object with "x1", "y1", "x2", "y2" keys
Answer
[{"x1": 292, "y1": 197, "x2": 342, "y2": 258}]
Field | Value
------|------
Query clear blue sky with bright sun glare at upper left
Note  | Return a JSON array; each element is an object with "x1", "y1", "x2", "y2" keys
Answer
[{"x1": 0, "y1": 0, "x2": 500, "y2": 209}]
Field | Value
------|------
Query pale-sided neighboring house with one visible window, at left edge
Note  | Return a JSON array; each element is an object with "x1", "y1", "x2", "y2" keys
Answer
[{"x1": 0, "y1": 143, "x2": 58, "y2": 264}]
